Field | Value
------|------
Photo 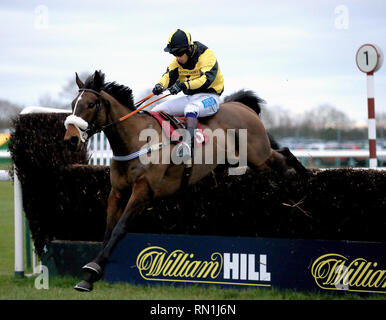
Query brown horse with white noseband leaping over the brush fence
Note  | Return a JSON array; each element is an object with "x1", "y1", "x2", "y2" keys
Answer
[{"x1": 64, "y1": 71, "x2": 307, "y2": 291}]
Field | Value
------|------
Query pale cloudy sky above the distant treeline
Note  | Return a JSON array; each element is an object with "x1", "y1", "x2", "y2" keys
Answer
[{"x1": 0, "y1": 0, "x2": 386, "y2": 121}]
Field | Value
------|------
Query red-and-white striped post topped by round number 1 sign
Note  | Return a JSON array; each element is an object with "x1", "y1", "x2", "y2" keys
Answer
[{"x1": 356, "y1": 44, "x2": 383, "y2": 168}]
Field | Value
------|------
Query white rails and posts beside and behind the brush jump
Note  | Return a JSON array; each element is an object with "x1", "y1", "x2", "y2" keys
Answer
[{"x1": 0, "y1": 107, "x2": 386, "y2": 276}]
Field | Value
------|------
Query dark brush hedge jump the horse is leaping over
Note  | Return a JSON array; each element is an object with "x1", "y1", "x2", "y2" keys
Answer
[{"x1": 9, "y1": 114, "x2": 386, "y2": 254}]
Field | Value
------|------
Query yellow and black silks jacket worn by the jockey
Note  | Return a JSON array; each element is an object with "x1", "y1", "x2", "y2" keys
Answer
[{"x1": 158, "y1": 41, "x2": 224, "y2": 95}]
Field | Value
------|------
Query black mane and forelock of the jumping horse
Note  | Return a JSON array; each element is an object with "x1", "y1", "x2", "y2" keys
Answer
[{"x1": 83, "y1": 70, "x2": 134, "y2": 109}]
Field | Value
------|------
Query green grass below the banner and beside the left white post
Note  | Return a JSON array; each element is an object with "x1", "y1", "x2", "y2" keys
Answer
[{"x1": 0, "y1": 181, "x2": 386, "y2": 300}]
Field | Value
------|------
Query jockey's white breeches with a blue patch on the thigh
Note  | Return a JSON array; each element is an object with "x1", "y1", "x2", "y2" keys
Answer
[{"x1": 152, "y1": 93, "x2": 220, "y2": 117}]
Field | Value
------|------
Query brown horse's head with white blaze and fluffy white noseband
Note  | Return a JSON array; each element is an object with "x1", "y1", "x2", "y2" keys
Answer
[{"x1": 64, "y1": 71, "x2": 109, "y2": 151}]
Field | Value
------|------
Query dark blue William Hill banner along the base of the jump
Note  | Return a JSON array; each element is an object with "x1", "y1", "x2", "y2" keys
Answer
[{"x1": 104, "y1": 234, "x2": 386, "y2": 293}]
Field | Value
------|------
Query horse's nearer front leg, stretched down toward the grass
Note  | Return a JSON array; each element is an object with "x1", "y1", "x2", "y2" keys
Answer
[{"x1": 75, "y1": 179, "x2": 150, "y2": 291}]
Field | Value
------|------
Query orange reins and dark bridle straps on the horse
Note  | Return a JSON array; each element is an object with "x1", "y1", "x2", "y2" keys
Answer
[{"x1": 79, "y1": 89, "x2": 171, "y2": 140}]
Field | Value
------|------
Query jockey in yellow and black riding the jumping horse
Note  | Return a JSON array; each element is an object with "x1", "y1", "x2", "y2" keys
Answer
[{"x1": 152, "y1": 29, "x2": 224, "y2": 158}]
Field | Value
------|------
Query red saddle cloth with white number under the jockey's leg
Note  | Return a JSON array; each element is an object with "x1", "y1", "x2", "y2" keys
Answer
[{"x1": 147, "y1": 111, "x2": 209, "y2": 145}]
